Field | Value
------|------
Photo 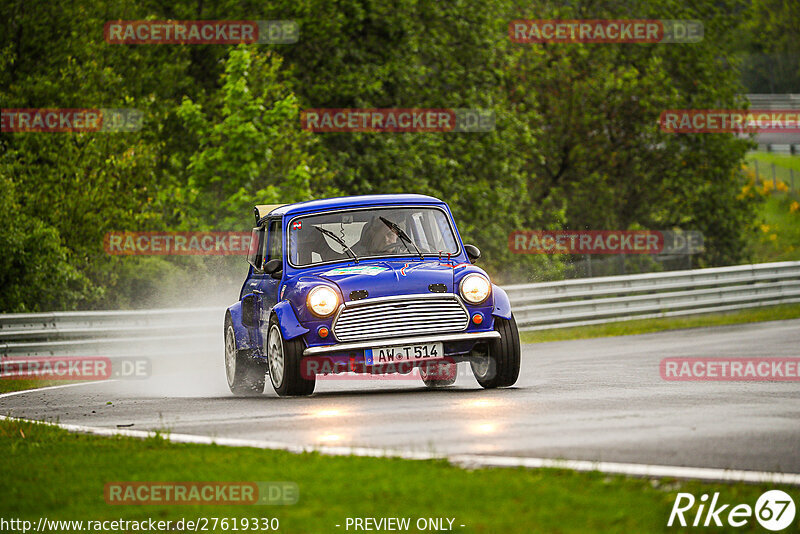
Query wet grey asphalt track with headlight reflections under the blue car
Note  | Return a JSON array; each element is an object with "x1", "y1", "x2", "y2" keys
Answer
[{"x1": 0, "y1": 320, "x2": 800, "y2": 473}]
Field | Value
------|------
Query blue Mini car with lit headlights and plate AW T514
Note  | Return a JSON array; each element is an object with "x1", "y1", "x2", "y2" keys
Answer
[{"x1": 225, "y1": 195, "x2": 520, "y2": 396}]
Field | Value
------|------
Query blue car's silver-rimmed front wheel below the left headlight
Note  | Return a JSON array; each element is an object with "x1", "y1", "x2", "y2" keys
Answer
[{"x1": 264, "y1": 315, "x2": 317, "y2": 397}]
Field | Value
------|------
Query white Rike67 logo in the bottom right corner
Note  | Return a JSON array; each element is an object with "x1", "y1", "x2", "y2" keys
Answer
[{"x1": 667, "y1": 490, "x2": 796, "y2": 532}]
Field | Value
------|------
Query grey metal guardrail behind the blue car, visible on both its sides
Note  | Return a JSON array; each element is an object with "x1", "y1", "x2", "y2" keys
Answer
[{"x1": 0, "y1": 261, "x2": 800, "y2": 356}]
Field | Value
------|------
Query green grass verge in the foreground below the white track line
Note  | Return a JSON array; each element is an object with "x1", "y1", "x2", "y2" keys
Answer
[{"x1": 0, "y1": 421, "x2": 800, "y2": 533}]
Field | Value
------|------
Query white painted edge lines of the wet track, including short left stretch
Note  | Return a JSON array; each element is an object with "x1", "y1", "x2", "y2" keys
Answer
[{"x1": 0, "y1": 388, "x2": 800, "y2": 486}]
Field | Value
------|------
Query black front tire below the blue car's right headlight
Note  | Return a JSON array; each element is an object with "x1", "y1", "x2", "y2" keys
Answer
[{"x1": 470, "y1": 315, "x2": 520, "y2": 389}]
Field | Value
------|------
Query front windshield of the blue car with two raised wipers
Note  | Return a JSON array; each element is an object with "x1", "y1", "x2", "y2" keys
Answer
[{"x1": 288, "y1": 207, "x2": 458, "y2": 267}]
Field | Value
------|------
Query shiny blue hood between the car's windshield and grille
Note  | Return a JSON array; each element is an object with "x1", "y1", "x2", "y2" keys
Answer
[{"x1": 303, "y1": 260, "x2": 462, "y2": 301}]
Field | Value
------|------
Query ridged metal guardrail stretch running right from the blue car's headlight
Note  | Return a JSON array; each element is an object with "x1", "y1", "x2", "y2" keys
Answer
[{"x1": 504, "y1": 261, "x2": 800, "y2": 330}]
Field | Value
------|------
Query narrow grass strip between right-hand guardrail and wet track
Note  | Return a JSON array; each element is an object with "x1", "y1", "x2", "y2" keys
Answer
[{"x1": 520, "y1": 304, "x2": 800, "y2": 343}]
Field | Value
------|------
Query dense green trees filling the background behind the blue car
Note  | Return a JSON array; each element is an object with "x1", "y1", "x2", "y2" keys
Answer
[{"x1": 0, "y1": 0, "x2": 768, "y2": 310}]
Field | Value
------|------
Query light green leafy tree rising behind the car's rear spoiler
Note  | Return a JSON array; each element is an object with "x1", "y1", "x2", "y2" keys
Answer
[{"x1": 176, "y1": 45, "x2": 325, "y2": 228}]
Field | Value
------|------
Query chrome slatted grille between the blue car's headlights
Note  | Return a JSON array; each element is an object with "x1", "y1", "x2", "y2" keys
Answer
[{"x1": 333, "y1": 294, "x2": 469, "y2": 341}]
